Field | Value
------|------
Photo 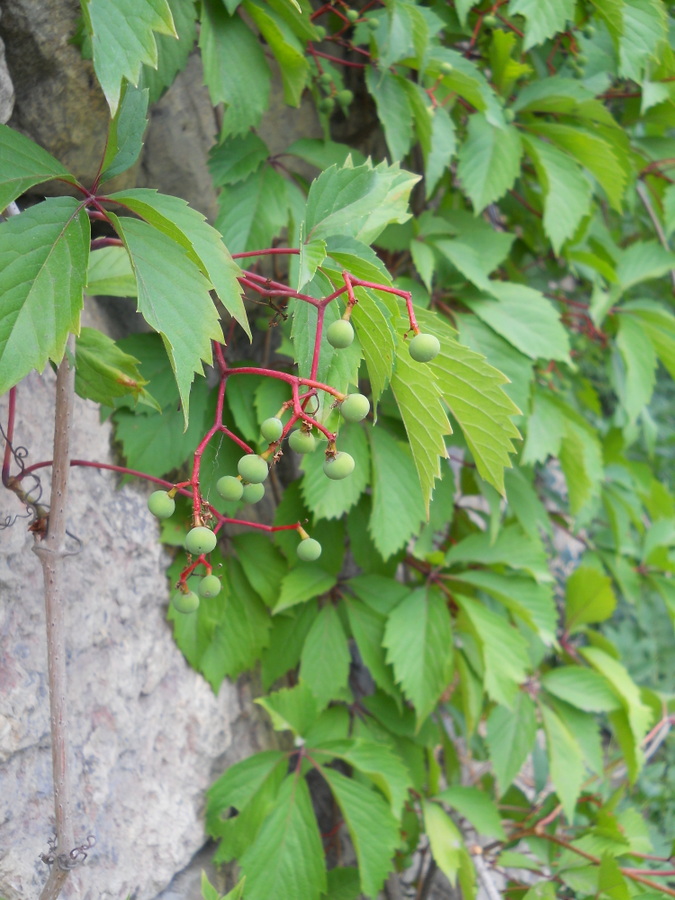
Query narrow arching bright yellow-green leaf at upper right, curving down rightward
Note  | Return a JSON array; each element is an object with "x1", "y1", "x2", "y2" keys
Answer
[{"x1": 529, "y1": 120, "x2": 626, "y2": 211}]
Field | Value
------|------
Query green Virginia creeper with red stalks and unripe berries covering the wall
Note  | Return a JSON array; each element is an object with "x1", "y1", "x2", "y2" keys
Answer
[{"x1": 0, "y1": 0, "x2": 675, "y2": 900}]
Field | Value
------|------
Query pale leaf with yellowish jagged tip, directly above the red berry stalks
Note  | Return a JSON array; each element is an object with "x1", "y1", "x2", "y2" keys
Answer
[{"x1": 305, "y1": 162, "x2": 420, "y2": 244}]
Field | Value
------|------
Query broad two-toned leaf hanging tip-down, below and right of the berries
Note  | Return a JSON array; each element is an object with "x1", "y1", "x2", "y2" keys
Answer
[{"x1": 384, "y1": 588, "x2": 453, "y2": 728}]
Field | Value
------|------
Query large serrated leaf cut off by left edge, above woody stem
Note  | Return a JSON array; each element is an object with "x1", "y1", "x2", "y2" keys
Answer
[{"x1": 0, "y1": 197, "x2": 90, "y2": 394}]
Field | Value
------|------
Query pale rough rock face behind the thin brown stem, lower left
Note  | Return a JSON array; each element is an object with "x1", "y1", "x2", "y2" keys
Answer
[{"x1": 0, "y1": 356, "x2": 269, "y2": 900}]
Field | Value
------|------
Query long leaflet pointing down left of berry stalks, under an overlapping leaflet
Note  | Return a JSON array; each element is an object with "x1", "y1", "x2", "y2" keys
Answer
[{"x1": 109, "y1": 213, "x2": 223, "y2": 427}]
